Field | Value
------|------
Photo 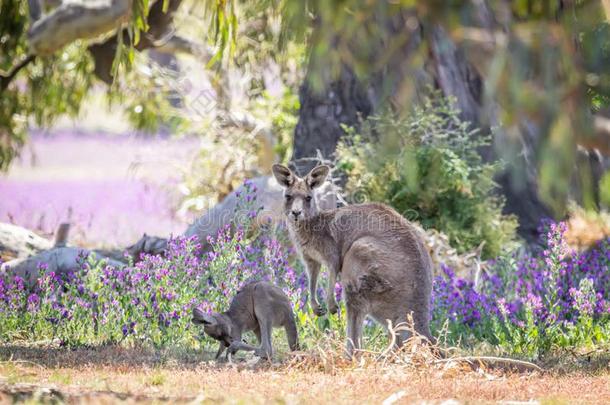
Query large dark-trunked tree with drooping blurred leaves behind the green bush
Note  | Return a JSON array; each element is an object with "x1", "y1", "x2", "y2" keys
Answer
[{"x1": 285, "y1": 0, "x2": 610, "y2": 239}]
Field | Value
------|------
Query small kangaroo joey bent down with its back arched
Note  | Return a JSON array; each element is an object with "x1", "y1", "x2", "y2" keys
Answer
[{"x1": 193, "y1": 281, "x2": 298, "y2": 359}]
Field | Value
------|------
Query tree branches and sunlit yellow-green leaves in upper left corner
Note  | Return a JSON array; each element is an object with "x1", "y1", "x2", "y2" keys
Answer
[{"x1": 0, "y1": 0, "x2": 221, "y2": 169}]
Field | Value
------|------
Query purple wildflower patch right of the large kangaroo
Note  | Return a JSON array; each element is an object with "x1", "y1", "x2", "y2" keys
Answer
[{"x1": 433, "y1": 223, "x2": 610, "y2": 357}]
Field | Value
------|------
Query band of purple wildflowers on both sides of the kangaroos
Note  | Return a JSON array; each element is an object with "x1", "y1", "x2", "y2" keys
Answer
[{"x1": 0, "y1": 174, "x2": 610, "y2": 358}]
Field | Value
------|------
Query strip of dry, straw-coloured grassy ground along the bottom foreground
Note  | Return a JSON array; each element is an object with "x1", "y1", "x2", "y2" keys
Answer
[{"x1": 0, "y1": 346, "x2": 610, "y2": 404}]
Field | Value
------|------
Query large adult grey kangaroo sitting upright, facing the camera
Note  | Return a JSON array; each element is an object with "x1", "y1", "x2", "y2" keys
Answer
[{"x1": 273, "y1": 164, "x2": 432, "y2": 356}]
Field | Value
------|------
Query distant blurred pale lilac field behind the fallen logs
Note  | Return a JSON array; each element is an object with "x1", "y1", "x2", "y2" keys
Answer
[{"x1": 0, "y1": 132, "x2": 196, "y2": 246}]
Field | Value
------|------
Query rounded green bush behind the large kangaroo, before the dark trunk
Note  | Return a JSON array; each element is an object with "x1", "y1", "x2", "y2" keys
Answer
[{"x1": 337, "y1": 97, "x2": 517, "y2": 258}]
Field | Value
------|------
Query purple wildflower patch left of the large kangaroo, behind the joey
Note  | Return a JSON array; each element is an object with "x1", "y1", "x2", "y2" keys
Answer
[{"x1": 0, "y1": 183, "x2": 305, "y2": 346}]
